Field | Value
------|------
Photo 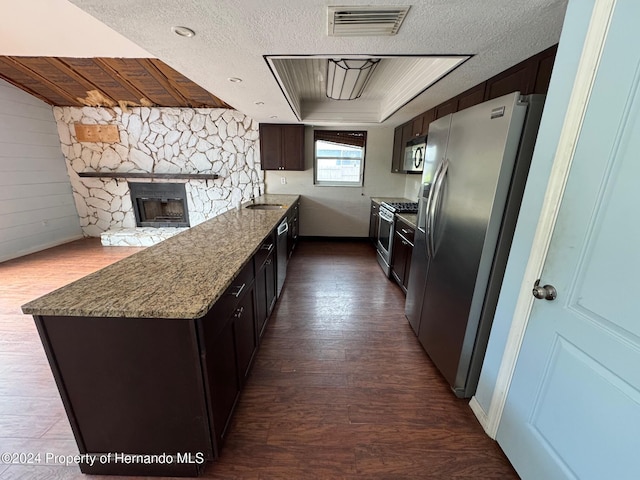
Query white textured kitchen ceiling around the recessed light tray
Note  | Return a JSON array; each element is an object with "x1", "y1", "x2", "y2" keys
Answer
[{"x1": 5, "y1": 0, "x2": 567, "y2": 126}]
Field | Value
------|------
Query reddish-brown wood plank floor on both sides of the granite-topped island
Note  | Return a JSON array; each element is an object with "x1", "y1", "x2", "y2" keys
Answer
[{"x1": 0, "y1": 240, "x2": 518, "y2": 480}]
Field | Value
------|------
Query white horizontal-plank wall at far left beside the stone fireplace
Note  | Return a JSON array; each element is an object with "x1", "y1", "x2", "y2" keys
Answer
[{"x1": 0, "y1": 80, "x2": 82, "y2": 261}]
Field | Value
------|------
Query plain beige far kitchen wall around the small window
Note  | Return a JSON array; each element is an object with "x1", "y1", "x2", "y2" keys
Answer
[{"x1": 265, "y1": 127, "x2": 410, "y2": 237}]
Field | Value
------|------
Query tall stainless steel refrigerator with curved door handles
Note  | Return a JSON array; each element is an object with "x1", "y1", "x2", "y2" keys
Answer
[{"x1": 405, "y1": 92, "x2": 544, "y2": 397}]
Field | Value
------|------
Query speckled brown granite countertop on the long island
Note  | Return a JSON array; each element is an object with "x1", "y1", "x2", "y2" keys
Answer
[{"x1": 22, "y1": 194, "x2": 299, "y2": 319}]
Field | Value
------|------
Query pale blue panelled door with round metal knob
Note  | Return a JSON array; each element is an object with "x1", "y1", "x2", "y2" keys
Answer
[{"x1": 497, "y1": 0, "x2": 640, "y2": 480}]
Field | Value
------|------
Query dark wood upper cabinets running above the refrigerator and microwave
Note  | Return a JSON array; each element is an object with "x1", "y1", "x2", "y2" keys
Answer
[{"x1": 391, "y1": 45, "x2": 557, "y2": 173}]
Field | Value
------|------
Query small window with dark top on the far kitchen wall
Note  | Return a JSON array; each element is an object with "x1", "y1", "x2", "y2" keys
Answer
[{"x1": 313, "y1": 130, "x2": 367, "y2": 187}]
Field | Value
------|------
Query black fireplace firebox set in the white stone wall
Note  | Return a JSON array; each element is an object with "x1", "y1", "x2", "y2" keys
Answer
[{"x1": 129, "y1": 182, "x2": 189, "y2": 227}]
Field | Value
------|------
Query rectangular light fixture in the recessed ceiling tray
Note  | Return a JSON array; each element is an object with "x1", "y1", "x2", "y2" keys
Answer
[{"x1": 327, "y1": 58, "x2": 380, "y2": 100}]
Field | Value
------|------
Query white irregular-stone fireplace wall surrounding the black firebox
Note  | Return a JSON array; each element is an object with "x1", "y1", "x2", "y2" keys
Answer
[{"x1": 54, "y1": 107, "x2": 264, "y2": 246}]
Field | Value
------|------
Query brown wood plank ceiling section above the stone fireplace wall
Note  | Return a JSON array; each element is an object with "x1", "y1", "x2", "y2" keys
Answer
[{"x1": 0, "y1": 56, "x2": 232, "y2": 110}]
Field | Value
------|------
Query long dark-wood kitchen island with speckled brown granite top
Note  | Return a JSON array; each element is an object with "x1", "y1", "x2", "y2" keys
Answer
[{"x1": 22, "y1": 195, "x2": 299, "y2": 476}]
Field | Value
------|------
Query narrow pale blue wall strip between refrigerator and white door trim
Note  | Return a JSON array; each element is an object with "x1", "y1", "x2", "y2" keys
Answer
[{"x1": 475, "y1": 0, "x2": 594, "y2": 414}]
